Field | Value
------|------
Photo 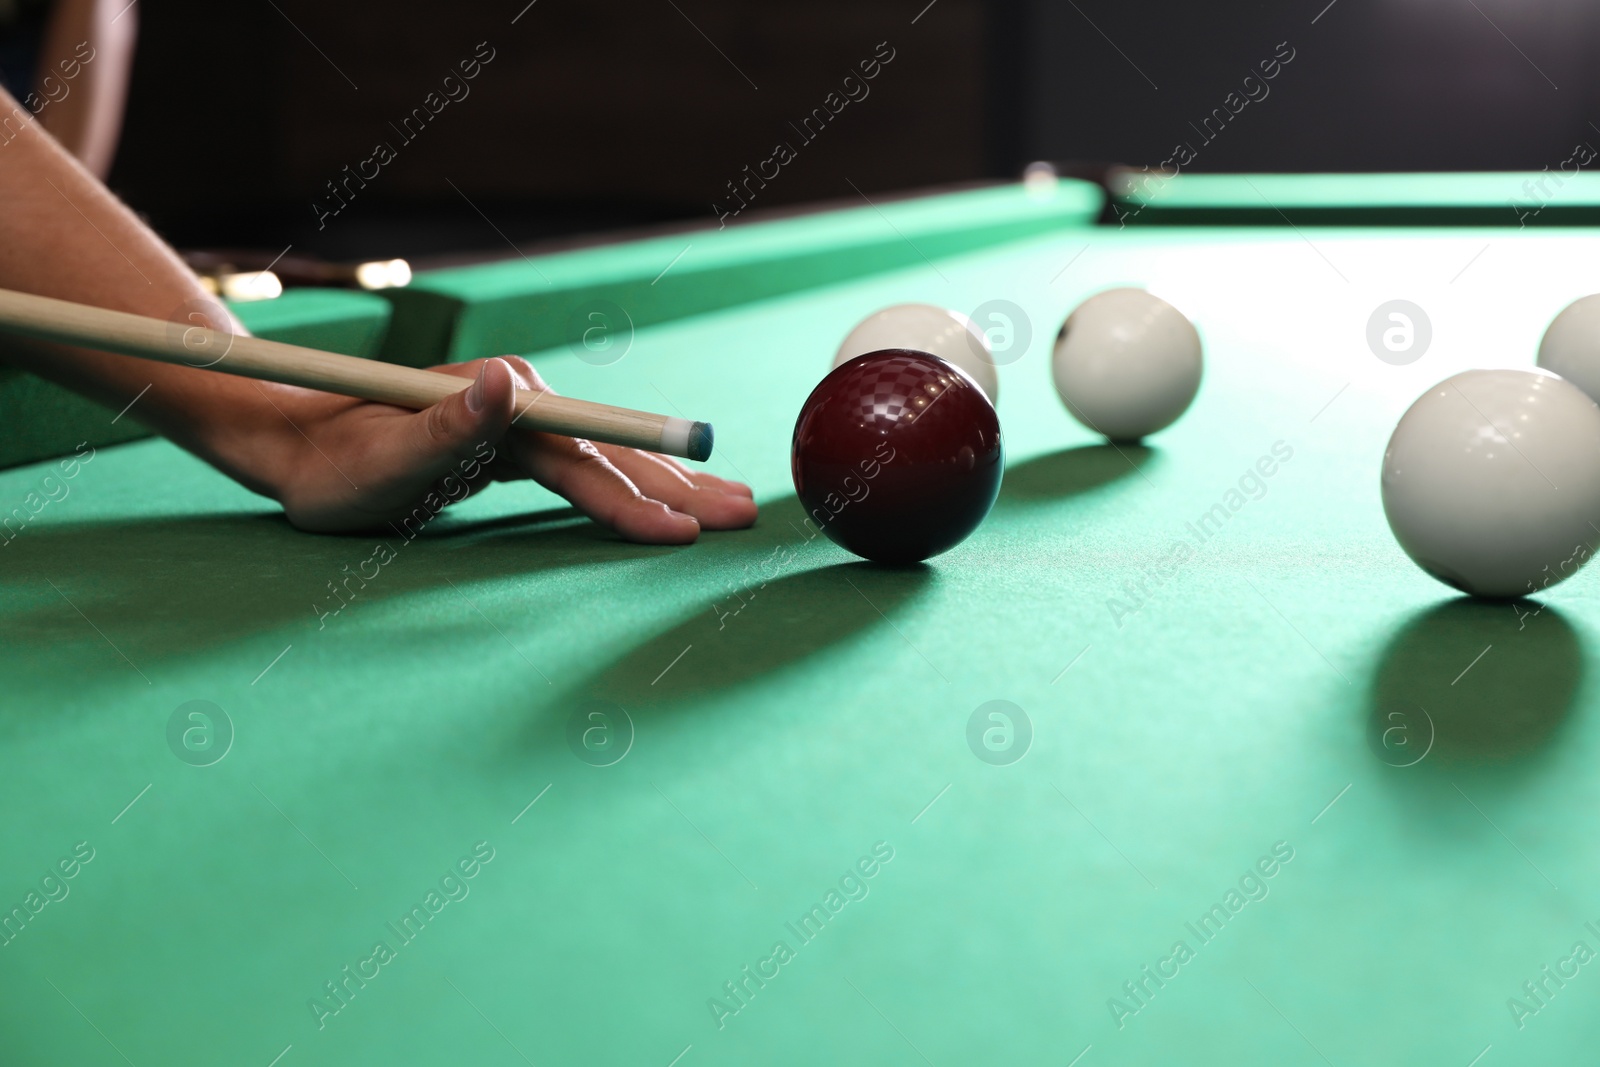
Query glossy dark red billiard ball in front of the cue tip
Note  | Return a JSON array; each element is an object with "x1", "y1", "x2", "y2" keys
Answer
[{"x1": 792, "y1": 349, "x2": 1005, "y2": 563}]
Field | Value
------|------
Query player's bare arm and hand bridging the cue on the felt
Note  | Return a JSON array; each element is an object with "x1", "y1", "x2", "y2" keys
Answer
[{"x1": 0, "y1": 91, "x2": 755, "y2": 544}]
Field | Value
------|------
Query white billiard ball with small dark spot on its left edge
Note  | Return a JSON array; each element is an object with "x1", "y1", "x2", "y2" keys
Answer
[{"x1": 1051, "y1": 290, "x2": 1202, "y2": 442}]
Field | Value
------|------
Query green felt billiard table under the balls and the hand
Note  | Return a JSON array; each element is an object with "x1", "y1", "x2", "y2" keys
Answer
[{"x1": 0, "y1": 174, "x2": 1600, "y2": 1067}]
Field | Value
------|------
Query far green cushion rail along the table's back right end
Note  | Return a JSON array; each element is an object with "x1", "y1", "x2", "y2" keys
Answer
[{"x1": 1110, "y1": 170, "x2": 1600, "y2": 229}]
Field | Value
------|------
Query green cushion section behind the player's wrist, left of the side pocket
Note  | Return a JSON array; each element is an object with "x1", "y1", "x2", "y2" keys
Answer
[{"x1": 0, "y1": 290, "x2": 389, "y2": 467}]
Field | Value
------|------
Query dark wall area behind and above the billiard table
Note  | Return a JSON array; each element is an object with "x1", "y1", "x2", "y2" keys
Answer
[{"x1": 110, "y1": 0, "x2": 1600, "y2": 256}]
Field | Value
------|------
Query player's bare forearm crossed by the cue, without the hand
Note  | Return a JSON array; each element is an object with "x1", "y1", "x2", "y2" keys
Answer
[{"x1": 0, "y1": 90, "x2": 294, "y2": 493}]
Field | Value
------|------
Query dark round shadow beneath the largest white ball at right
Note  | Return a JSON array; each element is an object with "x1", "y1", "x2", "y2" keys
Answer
[{"x1": 1366, "y1": 597, "x2": 1584, "y2": 768}]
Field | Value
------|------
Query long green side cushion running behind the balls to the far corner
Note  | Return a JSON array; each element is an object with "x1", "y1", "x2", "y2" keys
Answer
[{"x1": 382, "y1": 179, "x2": 1102, "y2": 366}]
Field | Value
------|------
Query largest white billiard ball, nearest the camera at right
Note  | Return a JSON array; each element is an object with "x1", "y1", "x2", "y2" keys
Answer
[{"x1": 1382, "y1": 370, "x2": 1600, "y2": 597}]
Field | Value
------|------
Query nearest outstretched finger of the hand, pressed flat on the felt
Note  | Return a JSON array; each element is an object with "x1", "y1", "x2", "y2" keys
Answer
[{"x1": 514, "y1": 434, "x2": 701, "y2": 544}]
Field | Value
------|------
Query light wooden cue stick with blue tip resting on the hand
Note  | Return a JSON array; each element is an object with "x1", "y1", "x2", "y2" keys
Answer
[{"x1": 0, "y1": 290, "x2": 712, "y2": 461}]
